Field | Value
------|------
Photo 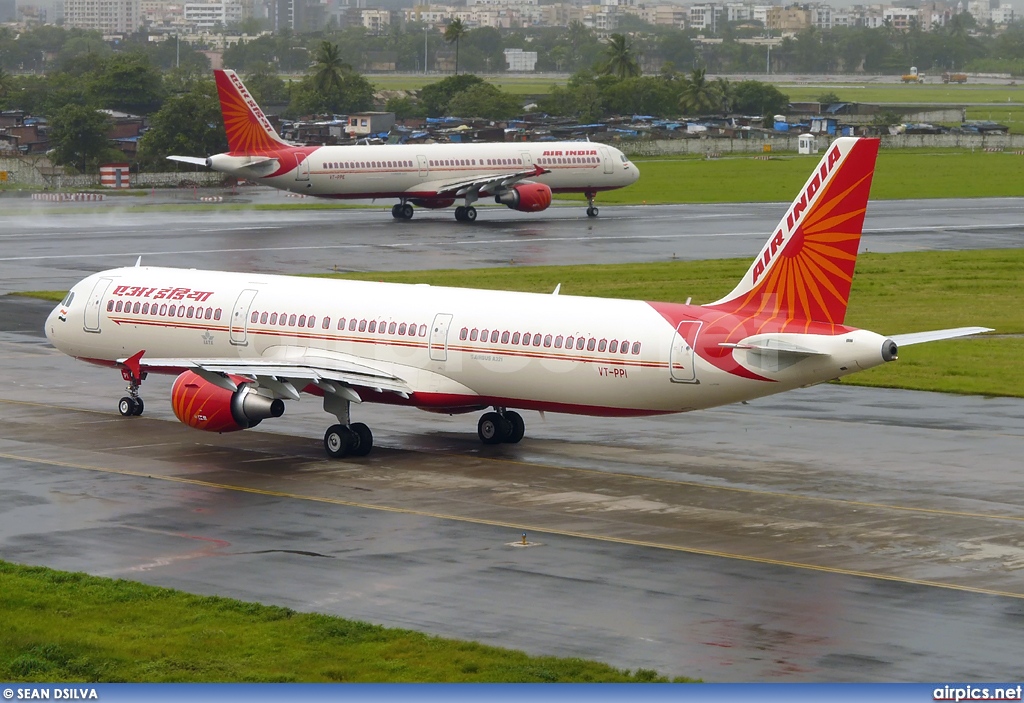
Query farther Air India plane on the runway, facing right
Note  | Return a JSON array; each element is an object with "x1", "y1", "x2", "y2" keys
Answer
[{"x1": 168, "y1": 71, "x2": 640, "y2": 222}]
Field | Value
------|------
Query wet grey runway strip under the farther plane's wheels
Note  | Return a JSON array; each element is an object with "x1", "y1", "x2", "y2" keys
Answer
[{"x1": 0, "y1": 189, "x2": 1024, "y2": 294}]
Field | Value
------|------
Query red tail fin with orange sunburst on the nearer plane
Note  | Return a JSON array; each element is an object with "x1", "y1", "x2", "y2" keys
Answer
[{"x1": 706, "y1": 137, "x2": 879, "y2": 324}]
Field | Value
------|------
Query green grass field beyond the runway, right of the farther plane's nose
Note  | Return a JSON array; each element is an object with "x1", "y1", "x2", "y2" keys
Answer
[{"x1": 585, "y1": 149, "x2": 1024, "y2": 205}]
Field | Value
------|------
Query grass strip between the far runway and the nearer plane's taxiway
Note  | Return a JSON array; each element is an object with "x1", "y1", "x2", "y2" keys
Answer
[{"x1": 16, "y1": 249, "x2": 1024, "y2": 397}]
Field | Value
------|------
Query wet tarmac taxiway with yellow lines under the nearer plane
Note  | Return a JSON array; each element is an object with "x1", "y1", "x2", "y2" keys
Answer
[{"x1": 0, "y1": 296, "x2": 1024, "y2": 680}]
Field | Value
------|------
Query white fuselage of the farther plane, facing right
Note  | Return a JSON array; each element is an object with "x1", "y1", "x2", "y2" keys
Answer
[{"x1": 209, "y1": 141, "x2": 640, "y2": 199}]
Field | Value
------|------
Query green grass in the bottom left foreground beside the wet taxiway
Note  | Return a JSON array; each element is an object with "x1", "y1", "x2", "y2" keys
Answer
[{"x1": 0, "y1": 562, "x2": 685, "y2": 683}]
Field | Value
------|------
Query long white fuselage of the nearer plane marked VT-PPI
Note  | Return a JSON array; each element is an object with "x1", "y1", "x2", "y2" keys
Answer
[{"x1": 46, "y1": 267, "x2": 885, "y2": 415}]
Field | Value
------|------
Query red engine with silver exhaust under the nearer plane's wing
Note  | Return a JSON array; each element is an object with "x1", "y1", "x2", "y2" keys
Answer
[{"x1": 171, "y1": 371, "x2": 285, "y2": 432}]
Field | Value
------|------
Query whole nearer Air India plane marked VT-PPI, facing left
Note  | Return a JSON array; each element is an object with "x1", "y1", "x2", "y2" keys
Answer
[{"x1": 46, "y1": 138, "x2": 988, "y2": 457}]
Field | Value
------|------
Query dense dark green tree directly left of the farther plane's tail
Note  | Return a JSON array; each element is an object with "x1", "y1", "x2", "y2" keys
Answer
[{"x1": 138, "y1": 80, "x2": 227, "y2": 169}]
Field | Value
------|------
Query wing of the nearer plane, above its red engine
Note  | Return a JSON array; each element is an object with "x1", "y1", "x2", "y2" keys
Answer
[{"x1": 118, "y1": 352, "x2": 413, "y2": 402}]
